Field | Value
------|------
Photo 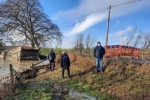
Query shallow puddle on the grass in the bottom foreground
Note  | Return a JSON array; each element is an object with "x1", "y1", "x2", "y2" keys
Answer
[{"x1": 27, "y1": 82, "x2": 97, "y2": 100}]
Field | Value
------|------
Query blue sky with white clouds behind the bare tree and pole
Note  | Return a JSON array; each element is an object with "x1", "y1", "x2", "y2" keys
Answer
[{"x1": 0, "y1": 0, "x2": 150, "y2": 48}]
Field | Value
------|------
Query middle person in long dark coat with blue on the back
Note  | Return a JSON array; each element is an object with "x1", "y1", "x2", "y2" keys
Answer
[{"x1": 60, "y1": 51, "x2": 71, "y2": 79}]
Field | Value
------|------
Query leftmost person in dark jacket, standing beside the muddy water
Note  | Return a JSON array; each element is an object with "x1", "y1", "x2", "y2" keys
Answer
[{"x1": 47, "y1": 48, "x2": 55, "y2": 71}]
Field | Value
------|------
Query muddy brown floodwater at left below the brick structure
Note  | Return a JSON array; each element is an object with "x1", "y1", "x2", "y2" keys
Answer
[{"x1": 0, "y1": 59, "x2": 48, "y2": 77}]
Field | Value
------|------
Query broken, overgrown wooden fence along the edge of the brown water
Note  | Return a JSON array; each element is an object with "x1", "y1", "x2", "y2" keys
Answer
[{"x1": 0, "y1": 60, "x2": 47, "y2": 100}]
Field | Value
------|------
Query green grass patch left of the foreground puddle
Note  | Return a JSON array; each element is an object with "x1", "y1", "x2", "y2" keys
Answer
[{"x1": 6, "y1": 82, "x2": 58, "y2": 100}]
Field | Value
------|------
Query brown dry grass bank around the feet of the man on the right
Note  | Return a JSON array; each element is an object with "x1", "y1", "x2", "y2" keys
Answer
[{"x1": 30, "y1": 54, "x2": 150, "y2": 100}]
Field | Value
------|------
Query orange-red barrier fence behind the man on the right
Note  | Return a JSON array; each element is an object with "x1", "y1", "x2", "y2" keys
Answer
[{"x1": 105, "y1": 45, "x2": 141, "y2": 58}]
